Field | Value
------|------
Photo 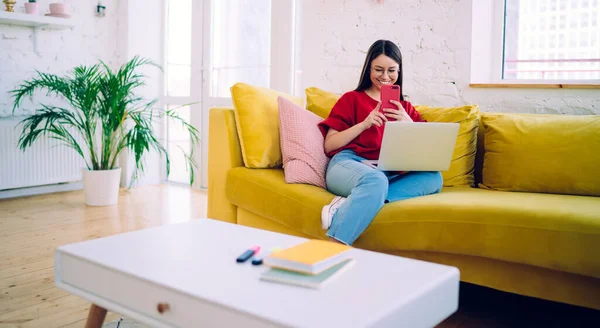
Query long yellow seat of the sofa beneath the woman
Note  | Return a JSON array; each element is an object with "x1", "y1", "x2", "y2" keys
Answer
[{"x1": 226, "y1": 167, "x2": 600, "y2": 278}]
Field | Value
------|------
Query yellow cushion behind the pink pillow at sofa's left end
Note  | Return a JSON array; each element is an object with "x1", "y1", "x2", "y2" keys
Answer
[{"x1": 231, "y1": 82, "x2": 302, "y2": 168}]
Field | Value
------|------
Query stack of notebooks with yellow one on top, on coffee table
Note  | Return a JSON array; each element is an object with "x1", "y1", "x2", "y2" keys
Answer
[{"x1": 260, "y1": 240, "x2": 352, "y2": 289}]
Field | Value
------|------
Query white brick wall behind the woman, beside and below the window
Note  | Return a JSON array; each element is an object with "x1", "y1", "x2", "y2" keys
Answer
[{"x1": 302, "y1": 0, "x2": 600, "y2": 114}]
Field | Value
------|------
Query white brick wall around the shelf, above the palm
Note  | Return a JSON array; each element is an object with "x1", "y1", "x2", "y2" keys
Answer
[{"x1": 0, "y1": 0, "x2": 118, "y2": 118}]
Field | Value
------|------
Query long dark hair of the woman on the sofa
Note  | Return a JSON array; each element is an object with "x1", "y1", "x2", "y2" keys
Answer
[{"x1": 355, "y1": 40, "x2": 404, "y2": 100}]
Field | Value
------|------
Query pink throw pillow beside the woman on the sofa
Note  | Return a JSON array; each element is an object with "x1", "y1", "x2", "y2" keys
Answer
[{"x1": 277, "y1": 97, "x2": 329, "y2": 188}]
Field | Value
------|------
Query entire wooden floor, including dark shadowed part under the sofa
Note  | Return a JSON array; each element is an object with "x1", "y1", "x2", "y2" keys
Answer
[{"x1": 0, "y1": 185, "x2": 600, "y2": 328}]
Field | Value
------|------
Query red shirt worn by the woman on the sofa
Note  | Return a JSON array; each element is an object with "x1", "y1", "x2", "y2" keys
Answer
[{"x1": 319, "y1": 91, "x2": 426, "y2": 160}]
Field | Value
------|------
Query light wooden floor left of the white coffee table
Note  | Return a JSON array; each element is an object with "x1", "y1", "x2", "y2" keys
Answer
[{"x1": 0, "y1": 185, "x2": 206, "y2": 328}]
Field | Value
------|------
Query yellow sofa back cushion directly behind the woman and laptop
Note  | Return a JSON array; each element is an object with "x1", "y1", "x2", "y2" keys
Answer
[{"x1": 306, "y1": 87, "x2": 479, "y2": 187}]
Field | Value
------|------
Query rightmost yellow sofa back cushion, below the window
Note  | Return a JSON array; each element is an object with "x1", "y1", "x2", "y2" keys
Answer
[{"x1": 480, "y1": 113, "x2": 600, "y2": 196}]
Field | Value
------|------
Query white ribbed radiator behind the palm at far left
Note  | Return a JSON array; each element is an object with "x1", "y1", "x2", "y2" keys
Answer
[{"x1": 0, "y1": 119, "x2": 85, "y2": 190}]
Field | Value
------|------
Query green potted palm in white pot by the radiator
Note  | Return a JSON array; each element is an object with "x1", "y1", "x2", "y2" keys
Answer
[{"x1": 11, "y1": 56, "x2": 199, "y2": 206}]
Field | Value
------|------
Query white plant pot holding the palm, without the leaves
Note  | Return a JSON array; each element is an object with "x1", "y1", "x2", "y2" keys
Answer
[{"x1": 81, "y1": 168, "x2": 121, "y2": 206}]
